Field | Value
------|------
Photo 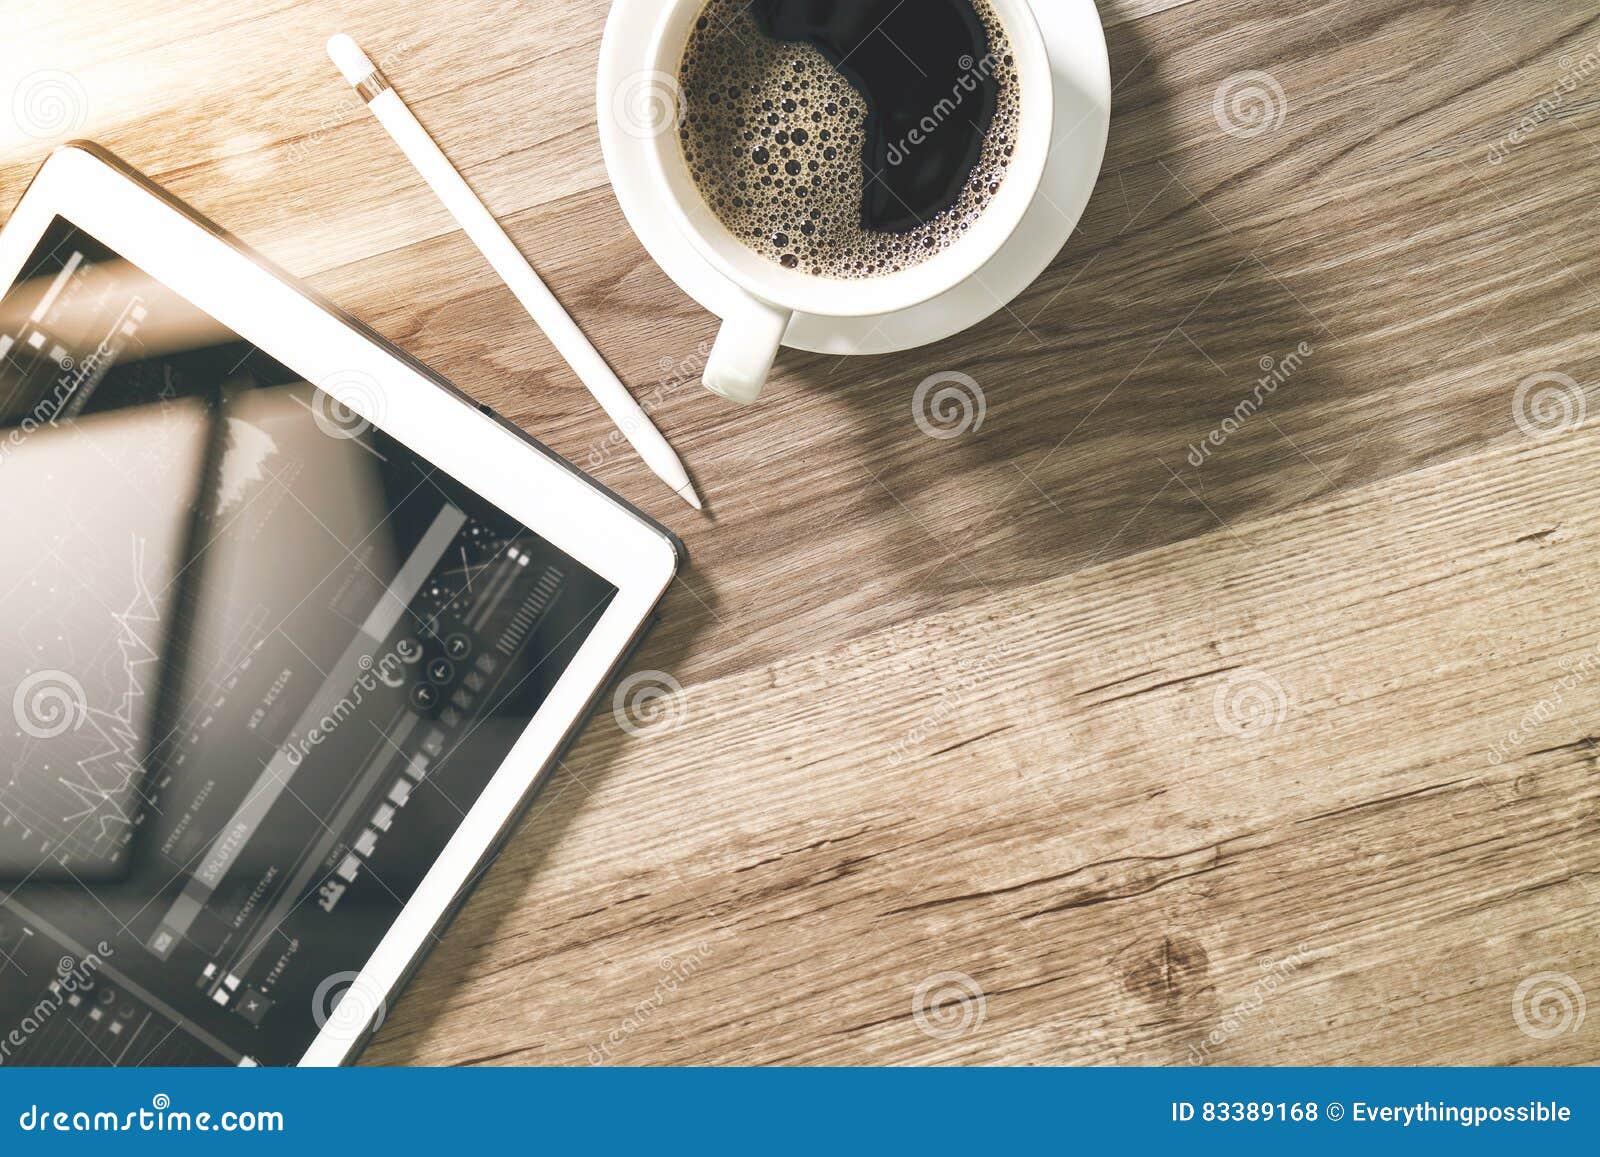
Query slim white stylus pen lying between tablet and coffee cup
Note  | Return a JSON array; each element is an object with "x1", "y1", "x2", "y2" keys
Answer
[{"x1": 328, "y1": 32, "x2": 701, "y2": 510}]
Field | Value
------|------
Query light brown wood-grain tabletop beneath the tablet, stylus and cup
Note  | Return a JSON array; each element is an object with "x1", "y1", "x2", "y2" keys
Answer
[{"x1": 0, "y1": 0, "x2": 1600, "y2": 1064}]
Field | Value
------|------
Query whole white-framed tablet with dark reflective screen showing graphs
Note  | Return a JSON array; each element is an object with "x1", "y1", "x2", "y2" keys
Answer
[{"x1": 0, "y1": 144, "x2": 680, "y2": 1064}]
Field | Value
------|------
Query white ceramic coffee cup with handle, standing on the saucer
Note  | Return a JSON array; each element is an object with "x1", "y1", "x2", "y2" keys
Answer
[{"x1": 630, "y1": 0, "x2": 1054, "y2": 402}]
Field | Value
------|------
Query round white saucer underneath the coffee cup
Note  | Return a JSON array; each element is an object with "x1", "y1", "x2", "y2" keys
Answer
[{"x1": 597, "y1": 0, "x2": 1110, "y2": 354}]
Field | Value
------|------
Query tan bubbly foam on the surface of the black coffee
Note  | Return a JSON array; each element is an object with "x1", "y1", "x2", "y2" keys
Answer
[{"x1": 678, "y1": 0, "x2": 1018, "y2": 278}]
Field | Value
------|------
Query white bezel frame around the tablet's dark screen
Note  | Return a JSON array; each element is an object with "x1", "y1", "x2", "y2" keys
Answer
[{"x1": 0, "y1": 144, "x2": 678, "y2": 1064}]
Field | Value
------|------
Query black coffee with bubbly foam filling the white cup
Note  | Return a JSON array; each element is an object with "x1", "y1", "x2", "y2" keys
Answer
[{"x1": 678, "y1": 0, "x2": 1018, "y2": 277}]
